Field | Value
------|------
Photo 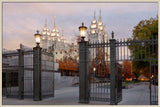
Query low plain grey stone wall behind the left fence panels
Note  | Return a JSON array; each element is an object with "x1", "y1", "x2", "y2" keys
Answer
[{"x1": 24, "y1": 70, "x2": 79, "y2": 92}]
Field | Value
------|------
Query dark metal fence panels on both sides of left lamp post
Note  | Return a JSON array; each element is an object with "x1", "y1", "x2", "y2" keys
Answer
[{"x1": 3, "y1": 49, "x2": 54, "y2": 99}]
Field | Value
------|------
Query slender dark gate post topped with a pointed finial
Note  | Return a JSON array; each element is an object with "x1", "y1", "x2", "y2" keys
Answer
[{"x1": 109, "y1": 31, "x2": 117, "y2": 105}]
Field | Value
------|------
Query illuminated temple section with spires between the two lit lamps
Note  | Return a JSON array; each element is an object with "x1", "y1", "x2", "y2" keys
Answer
[{"x1": 40, "y1": 16, "x2": 79, "y2": 62}]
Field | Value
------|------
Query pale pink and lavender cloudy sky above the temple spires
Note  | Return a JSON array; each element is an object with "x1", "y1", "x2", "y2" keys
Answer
[{"x1": 2, "y1": 3, "x2": 158, "y2": 50}]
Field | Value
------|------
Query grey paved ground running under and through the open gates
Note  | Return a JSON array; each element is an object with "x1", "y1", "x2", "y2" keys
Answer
[{"x1": 3, "y1": 84, "x2": 149, "y2": 105}]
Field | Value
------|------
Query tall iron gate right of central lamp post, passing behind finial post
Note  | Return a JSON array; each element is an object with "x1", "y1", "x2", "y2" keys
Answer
[{"x1": 87, "y1": 41, "x2": 122, "y2": 103}]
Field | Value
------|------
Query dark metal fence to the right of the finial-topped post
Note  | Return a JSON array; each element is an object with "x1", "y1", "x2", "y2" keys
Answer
[{"x1": 116, "y1": 36, "x2": 158, "y2": 105}]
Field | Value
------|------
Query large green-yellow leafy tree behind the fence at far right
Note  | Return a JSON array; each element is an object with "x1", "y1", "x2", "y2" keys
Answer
[{"x1": 129, "y1": 17, "x2": 158, "y2": 77}]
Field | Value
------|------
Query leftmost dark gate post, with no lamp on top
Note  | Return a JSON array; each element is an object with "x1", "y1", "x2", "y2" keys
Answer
[{"x1": 18, "y1": 49, "x2": 24, "y2": 99}]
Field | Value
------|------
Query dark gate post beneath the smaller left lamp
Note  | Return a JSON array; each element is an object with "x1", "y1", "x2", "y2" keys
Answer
[{"x1": 33, "y1": 45, "x2": 42, "y2": 101}]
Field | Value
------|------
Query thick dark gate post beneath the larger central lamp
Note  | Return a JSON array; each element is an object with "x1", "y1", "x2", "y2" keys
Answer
[{"x1": 79, "y1": 41, "x2": 89, "y2": 103}]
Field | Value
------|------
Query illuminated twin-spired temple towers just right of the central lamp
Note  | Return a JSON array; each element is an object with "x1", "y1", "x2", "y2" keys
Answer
[{"x1": 88, "y1": 10, "x2": 110, "y2": 61}]
